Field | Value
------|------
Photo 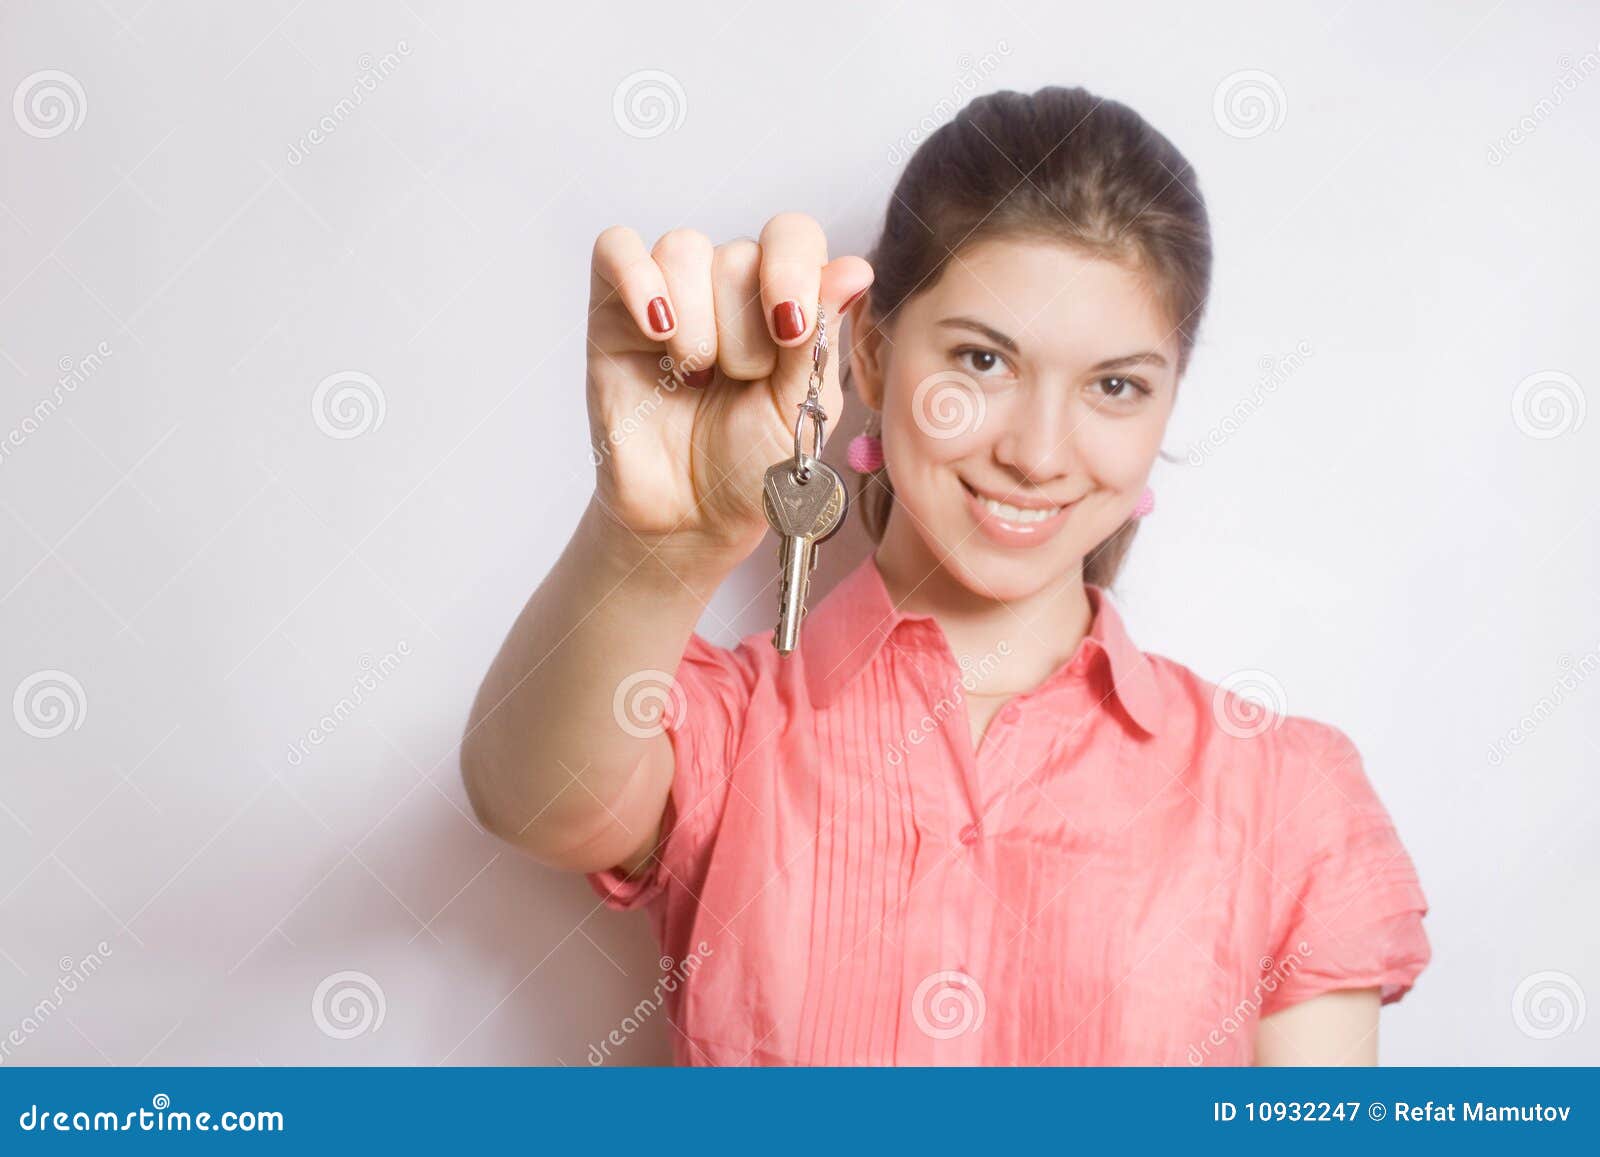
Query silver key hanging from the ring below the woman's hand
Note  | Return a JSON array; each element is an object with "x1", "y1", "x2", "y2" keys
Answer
[{"x1": 762, "y1": 454, "x2": 850, "y2": 655}]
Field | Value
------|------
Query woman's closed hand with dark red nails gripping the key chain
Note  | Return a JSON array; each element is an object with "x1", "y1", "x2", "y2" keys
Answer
[{"x1": 587, "y1": 213, "x2": 872, "y2": 557}]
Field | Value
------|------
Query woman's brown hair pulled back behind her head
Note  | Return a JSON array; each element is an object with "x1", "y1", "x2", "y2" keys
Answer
[{"x1": 845, "y1": 86, "x2": 1211, "y2": 587}]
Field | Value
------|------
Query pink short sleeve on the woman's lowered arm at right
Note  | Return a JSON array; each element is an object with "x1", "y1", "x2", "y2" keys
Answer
[{"x1": 1261, "y1": 720, "x2": 1430, "y2": 1016}]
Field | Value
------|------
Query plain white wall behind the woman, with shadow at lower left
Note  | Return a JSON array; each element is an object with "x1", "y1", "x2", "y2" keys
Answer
[{"x1": 0, "y1": 0, "x2": 1600, "y2": 1064}]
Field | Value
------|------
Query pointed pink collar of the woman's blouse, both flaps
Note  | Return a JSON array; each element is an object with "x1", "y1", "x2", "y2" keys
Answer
[{"x1": 800, "y1": 554, "x2": 1162, "y2": 735}]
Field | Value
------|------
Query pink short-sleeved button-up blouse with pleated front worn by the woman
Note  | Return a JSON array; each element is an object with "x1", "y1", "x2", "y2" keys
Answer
[{"x1": 589, "y1": 555, "x2": 1429, "y2": 1064}]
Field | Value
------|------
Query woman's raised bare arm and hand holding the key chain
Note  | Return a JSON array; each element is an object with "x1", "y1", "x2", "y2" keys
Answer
[{"x1": 461, "y1": 213, "x2": 872, "y2": 872}]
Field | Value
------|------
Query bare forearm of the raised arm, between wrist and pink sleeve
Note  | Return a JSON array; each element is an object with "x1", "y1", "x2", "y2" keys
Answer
[{"x1": 461, "y1": 492, "x2": 736, "y2": 863}]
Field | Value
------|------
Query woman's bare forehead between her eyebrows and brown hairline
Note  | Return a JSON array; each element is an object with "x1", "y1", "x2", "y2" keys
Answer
[{"x1": 917, "y1": 238, "x2": 1178, "y2": 362}]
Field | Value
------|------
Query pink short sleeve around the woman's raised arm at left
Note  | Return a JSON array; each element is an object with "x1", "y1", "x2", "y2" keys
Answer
[{"x1": 587, "y1": 634, "x2": 755, "y2": 911}]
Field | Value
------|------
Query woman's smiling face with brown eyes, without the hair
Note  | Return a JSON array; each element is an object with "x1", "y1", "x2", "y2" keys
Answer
[{"x1": 864, "y1": 240, "x2": 1179, "y2": 600}]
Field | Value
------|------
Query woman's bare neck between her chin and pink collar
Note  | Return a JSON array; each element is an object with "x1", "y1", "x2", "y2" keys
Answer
[{"x1": 874, "y1": 507, "x2": 1094, "y2": 696}]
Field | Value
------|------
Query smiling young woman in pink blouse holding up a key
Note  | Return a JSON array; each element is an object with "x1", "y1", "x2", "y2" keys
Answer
[{"x1": 462, "y1": 88, "x2": 1429, "y2": 1064}]
